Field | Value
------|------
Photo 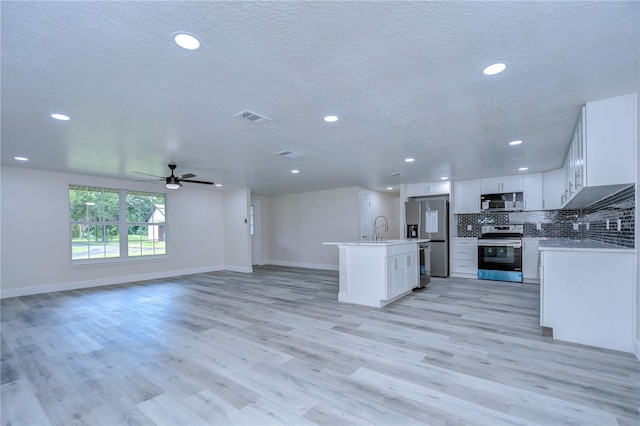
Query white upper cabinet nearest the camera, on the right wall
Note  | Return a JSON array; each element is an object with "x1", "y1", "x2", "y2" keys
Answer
[{"x1": 560, "y1": 93, "x2": 638, "y2": 209}]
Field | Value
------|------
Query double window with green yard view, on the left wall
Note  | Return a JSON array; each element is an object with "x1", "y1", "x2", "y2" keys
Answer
[{"x1": 69, "y1": 185, "x2": 167, "y2": 260}]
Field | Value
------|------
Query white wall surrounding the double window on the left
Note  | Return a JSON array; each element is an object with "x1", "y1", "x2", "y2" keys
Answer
[{"x1": 0, "y1": 167, "x2": 230, "y2": 297}]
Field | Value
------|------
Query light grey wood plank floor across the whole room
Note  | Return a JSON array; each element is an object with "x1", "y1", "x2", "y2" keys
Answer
[{"x1": 1, "y1": 267, "x2": 640, "y2": 425}]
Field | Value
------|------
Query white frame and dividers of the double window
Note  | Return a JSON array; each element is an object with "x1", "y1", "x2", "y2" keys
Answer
[{"x1": 67, "y1": 184, "x2": 171, "y2": 266}]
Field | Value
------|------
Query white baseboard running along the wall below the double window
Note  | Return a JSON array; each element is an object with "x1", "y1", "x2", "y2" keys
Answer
[{"x1": 0, "y1": 266, "x2": 248, "y2": 299}]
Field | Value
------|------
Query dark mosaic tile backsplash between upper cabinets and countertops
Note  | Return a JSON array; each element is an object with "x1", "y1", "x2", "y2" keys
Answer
[{"x1": 456, "y1": 185, "x2": 635, "y2": 248}]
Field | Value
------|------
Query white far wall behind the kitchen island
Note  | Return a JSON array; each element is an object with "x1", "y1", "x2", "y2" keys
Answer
[{"x1": 260, "y1": 186, "x2": 398, "y2": 270}]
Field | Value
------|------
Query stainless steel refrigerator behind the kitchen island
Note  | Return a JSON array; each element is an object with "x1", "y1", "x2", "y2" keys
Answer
[{"x1": 405, "y1": 197, "x2": 449, "y2": 277}]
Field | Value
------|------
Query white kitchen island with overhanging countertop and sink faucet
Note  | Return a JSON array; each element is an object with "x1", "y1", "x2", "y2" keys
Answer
[{"x1": 323, "y1": 239, "x2": 429, "y2": 308}]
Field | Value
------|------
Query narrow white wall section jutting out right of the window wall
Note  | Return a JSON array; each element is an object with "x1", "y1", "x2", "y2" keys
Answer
[{"x1": 224, "y1": 189, "x2": 252, "y2": 272}]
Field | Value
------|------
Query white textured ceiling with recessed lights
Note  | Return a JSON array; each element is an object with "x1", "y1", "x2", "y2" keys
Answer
[{"x1": 0, "y1": 1, "x2": 640, "y2": 195}]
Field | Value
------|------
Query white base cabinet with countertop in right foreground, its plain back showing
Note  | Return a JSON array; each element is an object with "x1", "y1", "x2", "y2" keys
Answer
[{"x1": 540, "y1": 246, "x2": 637, "y2": 352}]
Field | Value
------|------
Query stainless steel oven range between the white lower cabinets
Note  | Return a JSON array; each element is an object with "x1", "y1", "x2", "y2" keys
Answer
[{"x1": 478, "y1": 225, "x2": 523, "y2": 283}]
